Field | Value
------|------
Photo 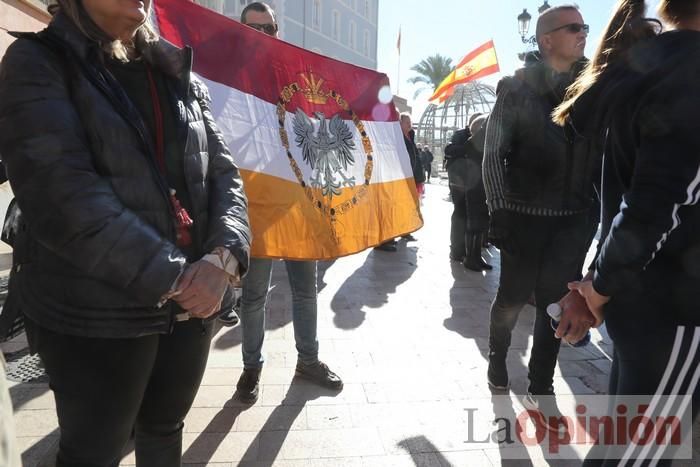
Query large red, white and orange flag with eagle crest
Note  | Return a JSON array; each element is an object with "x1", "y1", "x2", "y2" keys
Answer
[{"x1": 154, "y1": 0, "x2": 423, "y2": 260}]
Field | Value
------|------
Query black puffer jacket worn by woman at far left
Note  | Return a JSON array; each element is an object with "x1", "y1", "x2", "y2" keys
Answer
[{"x1": 0, "y1": 13, "x2": 250, "y2": 337}]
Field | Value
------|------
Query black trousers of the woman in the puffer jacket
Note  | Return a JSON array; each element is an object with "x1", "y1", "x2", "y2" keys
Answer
[{"x1": 27, "y1": 319, "x2": 213, "y2": 467}]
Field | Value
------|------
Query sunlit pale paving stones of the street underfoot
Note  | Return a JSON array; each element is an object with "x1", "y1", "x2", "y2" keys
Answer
[{"x1": 3, "y1": 179, "x2": 700, "y2": 467}]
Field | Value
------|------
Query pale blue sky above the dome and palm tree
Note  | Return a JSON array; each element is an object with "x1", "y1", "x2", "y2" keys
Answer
[{"x1": 377, "y1": 0, "x2": 656, "y2": 120}]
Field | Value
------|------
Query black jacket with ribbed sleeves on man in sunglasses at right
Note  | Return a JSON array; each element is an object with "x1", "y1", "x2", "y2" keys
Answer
[{"x1": 484, "y1": 58, "x2": 602, "y2": 215}]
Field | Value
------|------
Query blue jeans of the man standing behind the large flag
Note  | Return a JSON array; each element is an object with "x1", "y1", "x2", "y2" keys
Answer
[{"x1": 240, "y1": 258, "x2": 318, "y2": 369}]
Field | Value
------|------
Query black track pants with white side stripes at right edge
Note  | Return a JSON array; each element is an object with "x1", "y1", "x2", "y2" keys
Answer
[{"x1": 583, "y1": 295, "x2": 700, "y2": 467}]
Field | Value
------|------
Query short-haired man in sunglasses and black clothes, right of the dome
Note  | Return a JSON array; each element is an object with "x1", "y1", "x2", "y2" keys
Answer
[{"x1": 483, "y1": 5, "x2": 601, "y2": 428}]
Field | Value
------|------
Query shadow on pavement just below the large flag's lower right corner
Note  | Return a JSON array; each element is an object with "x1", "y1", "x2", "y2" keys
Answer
[{"x1": 331, "y1": 240, "x2": 418, "y2": 329}]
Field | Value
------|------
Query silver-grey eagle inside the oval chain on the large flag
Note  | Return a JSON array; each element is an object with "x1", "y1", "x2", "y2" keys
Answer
[{"x1": 292, "y1": 109, "x2": 355, "y2": 197}]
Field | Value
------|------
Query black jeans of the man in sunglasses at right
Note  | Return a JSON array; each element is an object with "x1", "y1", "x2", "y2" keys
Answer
[{"x1": 489, "y1": 213, "x2": 592, "y2": 394}]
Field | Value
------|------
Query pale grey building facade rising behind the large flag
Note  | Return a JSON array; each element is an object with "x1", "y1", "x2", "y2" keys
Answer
[{"x1": 196, "y1": 0, "x2": 379, "y2": 70}]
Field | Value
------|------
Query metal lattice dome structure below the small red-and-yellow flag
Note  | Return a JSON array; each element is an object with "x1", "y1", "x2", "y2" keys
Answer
[{"x1": 416, "y1": 81, "x2": 496, "y2": 162}]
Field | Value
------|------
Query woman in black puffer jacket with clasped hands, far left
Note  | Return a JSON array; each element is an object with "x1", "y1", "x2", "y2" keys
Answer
[{"x1": 0, "y1": 0, "x2": 250, "y2": 467}]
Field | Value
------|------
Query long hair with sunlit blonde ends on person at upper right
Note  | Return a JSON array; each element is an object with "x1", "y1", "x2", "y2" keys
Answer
[{"x1": 552, "y1": 0, "x2": 660, "y2": 125}]
